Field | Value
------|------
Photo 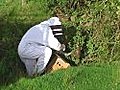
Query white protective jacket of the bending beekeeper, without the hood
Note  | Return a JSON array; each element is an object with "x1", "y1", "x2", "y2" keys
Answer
[{"x1": 18, "y1": 21, "x2": 61, "y2": 52}]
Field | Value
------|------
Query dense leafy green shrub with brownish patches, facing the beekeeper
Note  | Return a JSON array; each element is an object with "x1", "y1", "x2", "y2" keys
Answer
[{"x1": 49, "y1": 0, "x2": 120, "y2": 64}]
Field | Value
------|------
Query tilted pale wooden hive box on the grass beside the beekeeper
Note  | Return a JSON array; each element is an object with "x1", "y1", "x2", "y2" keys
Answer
[{"x1": 45, "y1": 54, "x2": 70, "y2": 73}]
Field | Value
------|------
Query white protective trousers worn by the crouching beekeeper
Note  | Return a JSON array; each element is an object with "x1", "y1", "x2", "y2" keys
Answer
[{"x1": 19, "y1": 45, "x2": 52, "y2": 76}]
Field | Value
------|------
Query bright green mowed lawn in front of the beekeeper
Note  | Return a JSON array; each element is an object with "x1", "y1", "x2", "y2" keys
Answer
[{"x1": 1, "y1": 62, "x2": 120, "y2": 90}]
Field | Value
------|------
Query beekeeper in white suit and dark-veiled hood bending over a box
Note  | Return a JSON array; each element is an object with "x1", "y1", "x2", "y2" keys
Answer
[{"x1": 18, "y1": 17, "x2": 65, "y2": 76}]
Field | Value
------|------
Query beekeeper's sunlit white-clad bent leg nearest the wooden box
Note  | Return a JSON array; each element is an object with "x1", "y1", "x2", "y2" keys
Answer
[{"x1": 35, "y1": 47, "x2": 52, "y2": 74}]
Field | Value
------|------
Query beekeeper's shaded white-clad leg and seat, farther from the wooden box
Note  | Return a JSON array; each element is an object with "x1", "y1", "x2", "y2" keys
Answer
[{"x1": 19, "y1": 44, "x2": 45, "y2": 76}]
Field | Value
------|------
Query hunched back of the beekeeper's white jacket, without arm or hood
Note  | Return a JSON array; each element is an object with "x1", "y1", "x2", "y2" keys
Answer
[{"x1": 18, "y1": 24, "x2": 49, "y2": 51}]
